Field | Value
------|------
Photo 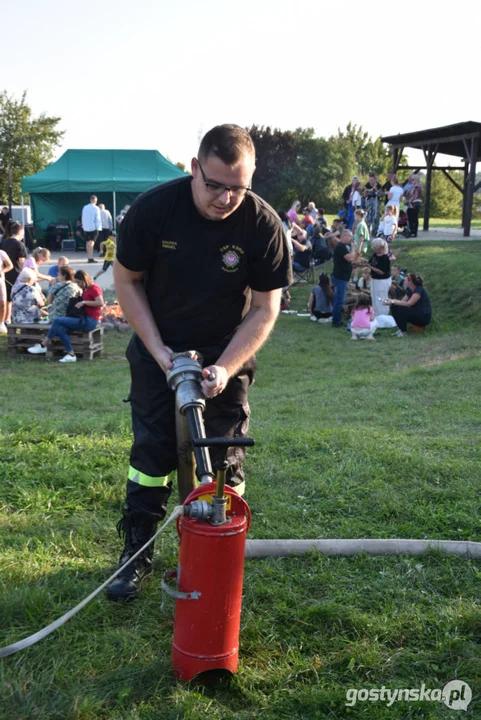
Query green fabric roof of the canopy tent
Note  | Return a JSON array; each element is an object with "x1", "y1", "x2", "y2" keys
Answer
[{"x1": 22, "y1": 150, "x2": 185, "y2": 193}]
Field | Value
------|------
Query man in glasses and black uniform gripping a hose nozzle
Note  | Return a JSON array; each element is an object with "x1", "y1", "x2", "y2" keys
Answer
[{"x1": 107, "y1": 125, "x2": 292, "y2": 600}]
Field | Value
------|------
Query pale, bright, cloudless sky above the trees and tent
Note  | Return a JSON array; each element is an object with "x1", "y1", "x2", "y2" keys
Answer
[{"x1": 0, "y1": 0, "x2": 481, "y2": 172}]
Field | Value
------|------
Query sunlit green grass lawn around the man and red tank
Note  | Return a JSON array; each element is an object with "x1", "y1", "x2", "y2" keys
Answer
[{"x1": 0, "y1": 241, "x2": 481, "y2": 720}]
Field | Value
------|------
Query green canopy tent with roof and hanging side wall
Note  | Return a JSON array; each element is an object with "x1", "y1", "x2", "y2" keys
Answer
[{"x1": 22, "y1": 150, "x2": 185, "y2": 239}]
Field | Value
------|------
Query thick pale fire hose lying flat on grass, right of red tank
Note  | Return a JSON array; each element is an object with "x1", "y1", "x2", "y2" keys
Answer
[{"x1": 245, "y1": 538, "x2": 481, "y2": 558}]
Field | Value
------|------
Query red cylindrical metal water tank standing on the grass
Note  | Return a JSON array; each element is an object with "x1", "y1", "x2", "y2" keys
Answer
[{"x1": 164, "y1": 483, "x2": 251, "y2": 681}]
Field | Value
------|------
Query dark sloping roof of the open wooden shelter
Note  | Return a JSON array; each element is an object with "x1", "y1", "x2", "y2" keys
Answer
[{"x1": 381, "y1": 120, "x2": 481, "y2": 160}]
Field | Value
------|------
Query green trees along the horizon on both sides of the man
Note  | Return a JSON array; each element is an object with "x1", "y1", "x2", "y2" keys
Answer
[{"x1": 0, "y1": 91, "x2": 472, "y2": 218}]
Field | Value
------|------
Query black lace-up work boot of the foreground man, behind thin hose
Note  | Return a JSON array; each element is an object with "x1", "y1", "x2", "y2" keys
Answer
[{"x1": 107, "y1": 509, "x2": 159, "y2": 600}]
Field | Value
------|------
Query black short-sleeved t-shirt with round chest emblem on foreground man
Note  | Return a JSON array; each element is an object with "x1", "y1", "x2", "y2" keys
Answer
[{"x1": 117, "y1": 177, "x2": 292, "y2": 351}]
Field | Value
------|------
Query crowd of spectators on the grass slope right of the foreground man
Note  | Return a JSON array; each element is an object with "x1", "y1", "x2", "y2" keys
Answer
[{"x1": 279, "y1": 173, "x2": 432, "y2": 340}]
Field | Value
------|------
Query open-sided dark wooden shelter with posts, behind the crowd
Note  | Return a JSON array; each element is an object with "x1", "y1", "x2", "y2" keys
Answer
[{"x1": 381, "y1": 121, "x2": 481, "y2": 237}]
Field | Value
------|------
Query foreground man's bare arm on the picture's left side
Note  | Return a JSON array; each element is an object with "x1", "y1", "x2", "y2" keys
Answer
[{"x1": 114, "y1": 260, "x2": 172, "y2": 372}]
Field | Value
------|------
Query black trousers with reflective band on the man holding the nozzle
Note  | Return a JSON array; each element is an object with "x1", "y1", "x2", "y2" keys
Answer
[{"x1": 127, "y1": 335, "x2": 255, "y2": 517}]
